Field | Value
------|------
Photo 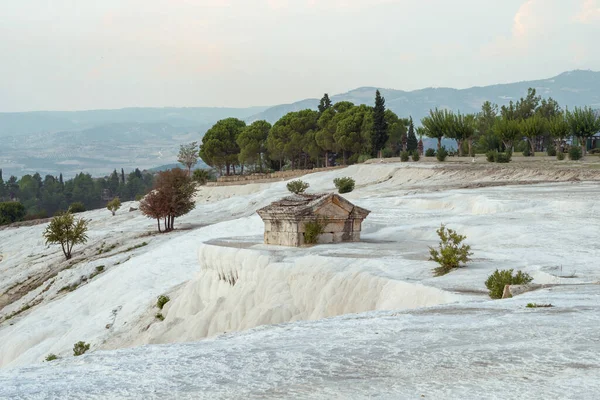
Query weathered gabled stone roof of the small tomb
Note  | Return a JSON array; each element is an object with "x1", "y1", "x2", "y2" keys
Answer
[{"x1": 257, "y1": 193, "x2": 370, "y2": 219}]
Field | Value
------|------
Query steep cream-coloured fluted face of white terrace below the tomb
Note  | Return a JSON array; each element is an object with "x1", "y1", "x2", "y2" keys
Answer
[{"x1": 123, "y1": 245, "x2": 464, "y2": 347}]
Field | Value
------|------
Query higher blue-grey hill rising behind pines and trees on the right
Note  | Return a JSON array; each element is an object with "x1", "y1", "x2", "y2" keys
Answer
[{"x1": 249, "y1": 70, "x2": 600, "y2": 123}]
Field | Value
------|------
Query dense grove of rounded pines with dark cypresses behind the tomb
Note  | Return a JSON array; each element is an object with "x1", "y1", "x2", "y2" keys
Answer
[{"x1": 199, "y1": 91, "x2": 418, "y2": 175}]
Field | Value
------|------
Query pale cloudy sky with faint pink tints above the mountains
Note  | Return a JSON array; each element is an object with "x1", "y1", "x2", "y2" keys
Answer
[{"x1": 0, "y1": 0, "x2": 600, "y2": 112}]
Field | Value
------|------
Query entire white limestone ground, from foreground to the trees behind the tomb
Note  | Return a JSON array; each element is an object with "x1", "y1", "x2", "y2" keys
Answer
[{"x1": 0, "y1": 164, "x2": 600, "y2": 398}]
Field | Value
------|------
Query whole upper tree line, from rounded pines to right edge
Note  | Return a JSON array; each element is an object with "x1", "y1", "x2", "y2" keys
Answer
[{"x1": 199, "y1": 89, "x2": 600, "y2": 175}]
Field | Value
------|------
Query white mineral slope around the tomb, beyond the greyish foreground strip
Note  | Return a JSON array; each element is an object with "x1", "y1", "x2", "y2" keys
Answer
[{"x1": 0, "y1": 164, "x2": 600, "y2": 367}]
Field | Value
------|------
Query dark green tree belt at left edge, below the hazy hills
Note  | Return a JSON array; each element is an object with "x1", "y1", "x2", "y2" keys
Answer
[{"x1": 0, "y1": 168, "x2": 154, "y2": 224}]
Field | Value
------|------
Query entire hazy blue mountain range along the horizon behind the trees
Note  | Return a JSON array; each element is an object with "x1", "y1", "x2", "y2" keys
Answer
[{"x1": 0, "y1": 70, "x2": 600, "y2": 177}]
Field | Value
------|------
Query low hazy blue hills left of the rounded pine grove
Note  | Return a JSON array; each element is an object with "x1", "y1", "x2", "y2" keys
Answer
[{"x1": 0, "y1": 107, "x2": 266, "y2": 177}]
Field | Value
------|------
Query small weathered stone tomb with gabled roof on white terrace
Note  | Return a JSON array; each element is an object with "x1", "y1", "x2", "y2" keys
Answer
[{"x1": 257, "y1": 193, "x2": 370, "y2": 247}]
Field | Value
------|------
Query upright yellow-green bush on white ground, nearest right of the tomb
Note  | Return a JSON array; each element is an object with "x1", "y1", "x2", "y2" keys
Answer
[{"x1": 429, "y1": 224, "x2": 473, "y2": 276}]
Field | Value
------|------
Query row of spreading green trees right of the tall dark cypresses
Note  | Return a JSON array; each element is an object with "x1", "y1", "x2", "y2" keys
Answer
[{"x1": 421, "y1": 88, "x2": 600, "y2": 156}]
